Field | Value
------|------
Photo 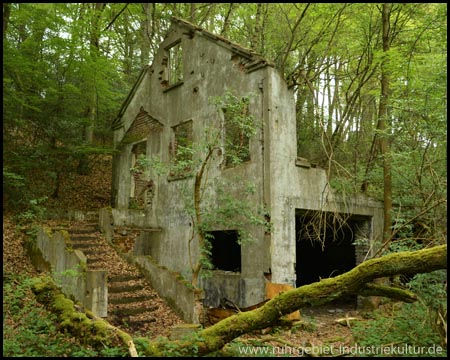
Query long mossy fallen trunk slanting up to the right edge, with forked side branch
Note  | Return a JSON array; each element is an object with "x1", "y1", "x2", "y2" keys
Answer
[{"x1": 140, "y1": 245, "x2": 447, "y2": 357}]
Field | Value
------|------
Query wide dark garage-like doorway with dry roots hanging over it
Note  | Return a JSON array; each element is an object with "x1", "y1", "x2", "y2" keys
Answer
[{"x1": 295, "y1": 211, "x2": 356, "y2": 287}]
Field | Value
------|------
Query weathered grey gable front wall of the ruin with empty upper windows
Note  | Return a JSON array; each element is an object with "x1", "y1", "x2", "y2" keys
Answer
[{"x1": 113, "y1": 24, "x2": 269, "y2": 286}]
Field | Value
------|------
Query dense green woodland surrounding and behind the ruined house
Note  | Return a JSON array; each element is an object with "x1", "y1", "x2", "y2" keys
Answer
[{"x1": 3, "y1": 3, "x2": 447, "y2": 355}]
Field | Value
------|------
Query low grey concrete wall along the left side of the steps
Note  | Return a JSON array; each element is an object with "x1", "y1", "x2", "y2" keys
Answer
[{"x1": 30, "y1": 227, "x2": 108, "y2": 317}]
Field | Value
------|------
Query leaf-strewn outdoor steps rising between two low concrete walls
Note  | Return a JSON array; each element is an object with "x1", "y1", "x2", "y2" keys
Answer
[{"x1": 68, "y1": 221, "x2": 183, "y2": 337}]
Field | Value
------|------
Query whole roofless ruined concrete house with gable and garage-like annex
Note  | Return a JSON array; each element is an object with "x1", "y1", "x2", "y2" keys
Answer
[{"x1": 112, "y1": 18, "x2": 383, "y2": 320}]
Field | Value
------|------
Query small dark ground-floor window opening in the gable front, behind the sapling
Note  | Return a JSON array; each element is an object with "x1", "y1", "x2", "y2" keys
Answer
[{"x1": 207, "y1": 230, "x2": 241, "y2": 272}]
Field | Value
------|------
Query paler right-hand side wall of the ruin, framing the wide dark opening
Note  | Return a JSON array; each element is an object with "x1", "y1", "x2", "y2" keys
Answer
[{"x1": 264, "y1": 69, "x2": 383, "y2": 286}]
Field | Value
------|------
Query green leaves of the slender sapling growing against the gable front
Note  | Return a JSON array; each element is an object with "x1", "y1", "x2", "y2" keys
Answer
[{"x1": 193, "y1": 91, "x2": 269, "y2": 277}]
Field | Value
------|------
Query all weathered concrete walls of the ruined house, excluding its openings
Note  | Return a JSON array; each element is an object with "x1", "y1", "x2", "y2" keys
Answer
[{"x1": 113, "y1": 23, "x2": 382, "y2": 307}]
